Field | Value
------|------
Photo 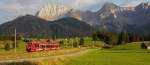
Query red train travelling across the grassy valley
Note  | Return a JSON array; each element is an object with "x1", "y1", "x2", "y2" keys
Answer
[{"x1": 26, "y1": 41, "x2": 60, "y2": 52}]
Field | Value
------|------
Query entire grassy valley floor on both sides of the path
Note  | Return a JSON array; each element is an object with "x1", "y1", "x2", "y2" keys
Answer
[{"x1": 0, "y1": 37, "x2": 150, "y2": 65}]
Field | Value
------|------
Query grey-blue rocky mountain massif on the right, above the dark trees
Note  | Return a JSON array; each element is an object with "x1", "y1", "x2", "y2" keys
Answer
[{"x1": 82, "y1": 3, "x2": 150, "y2": 34}]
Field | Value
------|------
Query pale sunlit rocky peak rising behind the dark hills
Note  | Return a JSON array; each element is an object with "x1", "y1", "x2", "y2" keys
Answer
[{"x1": 36, "y1": 4, "x2": 71, "y2": 21}]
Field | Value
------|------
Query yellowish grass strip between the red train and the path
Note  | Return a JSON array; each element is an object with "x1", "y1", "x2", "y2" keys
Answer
[{"x1": 0, "y1": 41, "x2": 86, "y2": 61}]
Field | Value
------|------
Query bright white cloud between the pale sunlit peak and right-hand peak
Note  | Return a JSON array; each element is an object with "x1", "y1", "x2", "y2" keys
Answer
[{"x1": 66, "y1": 0, "x2": 112, "y2": 11}]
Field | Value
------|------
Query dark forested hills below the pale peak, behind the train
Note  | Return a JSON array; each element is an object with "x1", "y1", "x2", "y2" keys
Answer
[{"x1": 0, "y1": 15, "x2": 92, "y2": 37}]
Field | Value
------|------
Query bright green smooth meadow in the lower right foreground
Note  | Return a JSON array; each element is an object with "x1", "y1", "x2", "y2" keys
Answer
[{"x1": 64, "y1": 50, "x2": 150, "y2": 65}]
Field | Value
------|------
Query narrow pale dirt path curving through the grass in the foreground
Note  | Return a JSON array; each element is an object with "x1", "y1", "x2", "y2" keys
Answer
[{"x1": 0, "y1": 49, "x2": 96, "y2": 64}]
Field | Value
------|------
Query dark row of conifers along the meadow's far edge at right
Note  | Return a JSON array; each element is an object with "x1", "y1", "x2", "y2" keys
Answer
[{"x1": 92, "y1": 31, "x2": 150, "y2": 46}]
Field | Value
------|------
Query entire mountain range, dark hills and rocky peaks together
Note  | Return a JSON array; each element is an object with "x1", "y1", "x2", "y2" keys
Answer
[{"x1": 0, "y1": 3, "x2": 150, "y2": 37}]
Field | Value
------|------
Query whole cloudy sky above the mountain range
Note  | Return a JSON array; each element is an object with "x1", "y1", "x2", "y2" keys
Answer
[{"x1": 0, "y1": 0, "x2": 150, "y2": 24}]
